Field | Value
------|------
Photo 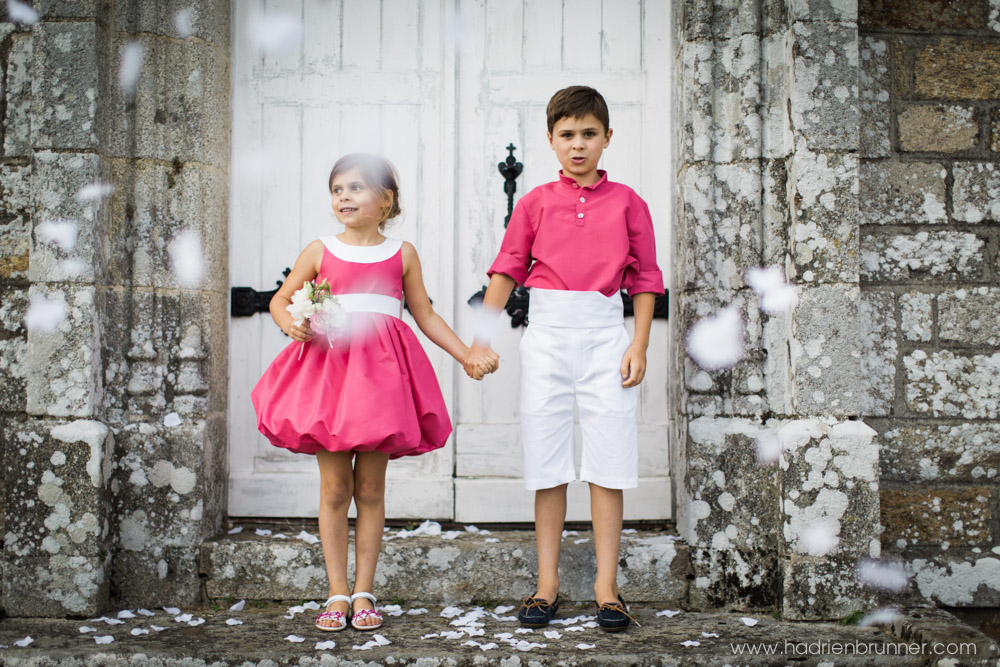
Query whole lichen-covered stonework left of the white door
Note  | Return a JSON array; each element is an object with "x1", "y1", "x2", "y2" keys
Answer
[{"x1": 0, "y1": 0, "x2": 229, "y2": 616}]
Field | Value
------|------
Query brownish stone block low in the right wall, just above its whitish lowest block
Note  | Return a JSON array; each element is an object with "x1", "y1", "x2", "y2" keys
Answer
[{"x1": 881, "y1": 486, "x2": 996, "y2": 549}]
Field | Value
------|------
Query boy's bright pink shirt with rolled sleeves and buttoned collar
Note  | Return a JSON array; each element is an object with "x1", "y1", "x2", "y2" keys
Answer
[{"x1": 487, "y1": 170, "x2": 663, "y2": 296}]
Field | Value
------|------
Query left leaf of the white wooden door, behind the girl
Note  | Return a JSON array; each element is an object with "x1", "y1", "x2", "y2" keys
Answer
[{"x1": 229, "y1": 0, "x2": 456, "y2": 518}]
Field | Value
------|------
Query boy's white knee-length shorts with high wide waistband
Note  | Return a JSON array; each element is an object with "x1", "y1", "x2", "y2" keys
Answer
[{"x1": 519, "y1": 288, "x2": 639, "y2": 490}]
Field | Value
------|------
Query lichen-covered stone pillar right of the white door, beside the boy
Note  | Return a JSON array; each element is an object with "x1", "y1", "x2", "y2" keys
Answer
[{"x1": 673, "y1": 0, "x2": 879, "y2": 618}]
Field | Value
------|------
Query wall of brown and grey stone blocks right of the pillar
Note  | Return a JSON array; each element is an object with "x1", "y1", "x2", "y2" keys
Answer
[{"x1": 859, "y1": 0, "x2": 1000, "y2": 606}]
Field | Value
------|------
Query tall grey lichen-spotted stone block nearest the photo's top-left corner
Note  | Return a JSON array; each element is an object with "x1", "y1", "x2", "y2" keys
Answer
[{"x1": 29, "y1": 22, "x2": 100, "y2": 150}]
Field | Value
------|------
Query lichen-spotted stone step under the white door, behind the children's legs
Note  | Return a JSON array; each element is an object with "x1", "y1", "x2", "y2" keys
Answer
[{"x1": 201, "y1": 524, "x2": 691, "y2": 607}]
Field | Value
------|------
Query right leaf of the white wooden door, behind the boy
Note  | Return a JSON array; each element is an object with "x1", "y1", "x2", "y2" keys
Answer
[{"x1": 455, "y1": 0, "x2": 671, "y2": 521}]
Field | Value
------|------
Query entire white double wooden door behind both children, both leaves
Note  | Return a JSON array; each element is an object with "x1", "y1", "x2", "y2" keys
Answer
[{"x1": 229, "y1": 0, "x2": 671, "y2": 521}]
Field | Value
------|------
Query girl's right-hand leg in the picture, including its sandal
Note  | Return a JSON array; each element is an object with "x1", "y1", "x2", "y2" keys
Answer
[{"x1": 354, "y1": 452, "x2": 389, "y2": 625}]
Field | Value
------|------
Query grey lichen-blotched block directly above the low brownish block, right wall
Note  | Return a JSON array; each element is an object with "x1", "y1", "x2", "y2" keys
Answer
[{"x1": 876, "y1": 422, "x2": 1000, "y2": 485}]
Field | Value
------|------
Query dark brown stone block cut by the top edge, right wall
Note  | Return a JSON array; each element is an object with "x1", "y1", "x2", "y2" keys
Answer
[{"x1": 858, "y1": 0, "x2": 985, "y2": 32}]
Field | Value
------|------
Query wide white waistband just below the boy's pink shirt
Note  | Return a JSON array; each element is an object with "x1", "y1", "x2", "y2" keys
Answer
[{"x1": 528, "y1": 287, "x2": 625, "y2": 329}]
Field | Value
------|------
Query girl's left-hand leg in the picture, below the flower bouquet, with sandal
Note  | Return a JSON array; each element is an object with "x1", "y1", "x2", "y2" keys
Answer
[{"x1": 316, "y1": 450, "x2": 354, "y2": 627}]
